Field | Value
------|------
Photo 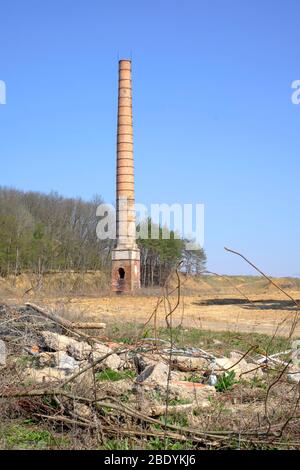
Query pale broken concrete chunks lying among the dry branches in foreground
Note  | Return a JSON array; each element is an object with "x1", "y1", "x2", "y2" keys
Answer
[{"x1": 0, "y1": 302, "x2": 300, "y2": 420}]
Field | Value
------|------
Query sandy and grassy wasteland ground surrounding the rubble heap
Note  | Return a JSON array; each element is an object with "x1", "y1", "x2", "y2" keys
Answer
[{"x1": 0, "y1": 273, "x2": 300, "y2": 449}]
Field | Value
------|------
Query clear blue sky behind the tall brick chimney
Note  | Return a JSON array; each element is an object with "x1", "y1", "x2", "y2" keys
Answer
[{"x1": 0, "y1": 0, "x2": 300, "y2": 276}]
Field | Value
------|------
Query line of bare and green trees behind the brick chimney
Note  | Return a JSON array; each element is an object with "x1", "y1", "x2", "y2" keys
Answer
[{"x1": 0, "y1": 187, "x2": 206, "y2": 286}]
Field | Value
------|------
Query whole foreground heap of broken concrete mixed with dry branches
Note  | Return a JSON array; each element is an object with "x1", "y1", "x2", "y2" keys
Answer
[{"x1": 0, "y1": 306, "x2": 300, "y2": 448}]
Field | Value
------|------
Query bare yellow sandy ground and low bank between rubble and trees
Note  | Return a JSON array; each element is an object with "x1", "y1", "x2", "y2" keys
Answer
[{"x1": 0, "y1": 274, "x2": 300, "y2": 336}]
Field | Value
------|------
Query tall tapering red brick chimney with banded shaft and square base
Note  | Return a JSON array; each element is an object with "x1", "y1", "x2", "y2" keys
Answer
[{"x1": 111, "y1": 60, "x2": 140, "y2": 292}]
